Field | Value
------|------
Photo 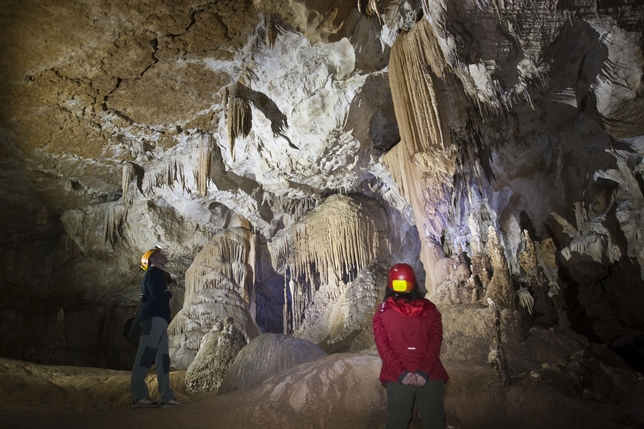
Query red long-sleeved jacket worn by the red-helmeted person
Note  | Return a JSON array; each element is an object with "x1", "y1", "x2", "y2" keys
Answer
[{"x1": 373, "y1": 297, "x2": 449, "y2": 385}]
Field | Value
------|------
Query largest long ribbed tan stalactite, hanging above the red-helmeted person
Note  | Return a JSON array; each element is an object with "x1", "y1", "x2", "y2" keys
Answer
[{"x1": 383, "y1": 20, "x2": 458, "y2": 239}]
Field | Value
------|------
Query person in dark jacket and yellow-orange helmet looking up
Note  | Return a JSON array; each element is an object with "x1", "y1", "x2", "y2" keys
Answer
[{"x1": 131, "y1": 247, "x2": 181, "y2": 408}]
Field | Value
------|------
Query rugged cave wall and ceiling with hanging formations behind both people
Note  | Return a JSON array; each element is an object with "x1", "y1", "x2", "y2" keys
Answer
[{"x1": 0, "y1": 0, "x2": 644, "y2": 368}]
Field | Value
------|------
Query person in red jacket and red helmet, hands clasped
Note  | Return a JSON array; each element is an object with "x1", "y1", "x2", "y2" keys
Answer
[{"x1": 373, "y1": 264, "x2": 449, "y2": 429}]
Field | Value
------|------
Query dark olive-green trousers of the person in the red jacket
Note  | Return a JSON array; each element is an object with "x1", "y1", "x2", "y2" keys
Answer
[{"x1": 387, "y1": 380, "x2": 445, "y2": 429}]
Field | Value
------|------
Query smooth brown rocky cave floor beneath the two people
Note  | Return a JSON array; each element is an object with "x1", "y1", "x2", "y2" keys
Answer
[{"x1": 0, "y1": 350, "x2": 644, "y2": 429}]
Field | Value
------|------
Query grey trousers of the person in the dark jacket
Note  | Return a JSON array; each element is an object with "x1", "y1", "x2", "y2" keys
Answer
[{"x1": 132, "y1": 317, "x2": 176, "y2": 402}]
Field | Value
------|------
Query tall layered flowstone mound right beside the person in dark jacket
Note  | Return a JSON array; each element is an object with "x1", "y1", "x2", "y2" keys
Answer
[{"x1": 168, "y1": 226, "x2": 261, "y2": 370}]
